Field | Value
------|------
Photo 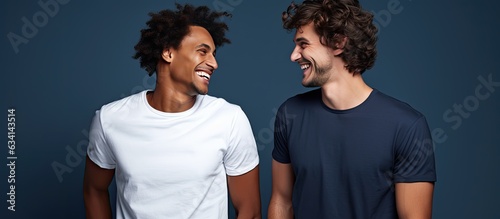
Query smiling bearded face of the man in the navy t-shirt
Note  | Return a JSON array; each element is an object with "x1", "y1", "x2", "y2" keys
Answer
[{"x1": 290, "y1": 23, "x2": 334, "y2": 87}]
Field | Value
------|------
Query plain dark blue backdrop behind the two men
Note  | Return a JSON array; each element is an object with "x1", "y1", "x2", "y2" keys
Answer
[{"x1": 0, "y1": 0, "x2": 500, "y2": 218}]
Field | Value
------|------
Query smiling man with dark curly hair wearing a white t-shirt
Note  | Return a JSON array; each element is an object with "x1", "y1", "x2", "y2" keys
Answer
[{"x1": 84, "y1": 4, "x2": 261, "y2": 218}]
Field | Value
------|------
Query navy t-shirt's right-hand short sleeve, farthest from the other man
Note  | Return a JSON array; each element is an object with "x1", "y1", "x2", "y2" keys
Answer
[{"x1": 394, "y1": 116, "x2": 436, "y2": 183}]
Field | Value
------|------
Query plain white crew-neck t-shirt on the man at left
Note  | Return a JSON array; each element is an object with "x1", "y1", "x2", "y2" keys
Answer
[{"x1": 87, "y1": 91, "x2": 259, "y2": 219}]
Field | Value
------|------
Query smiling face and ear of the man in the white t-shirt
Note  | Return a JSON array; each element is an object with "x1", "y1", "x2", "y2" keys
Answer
[{"x1": 162, "y1": 26, "x2": 218, "y2": 96}]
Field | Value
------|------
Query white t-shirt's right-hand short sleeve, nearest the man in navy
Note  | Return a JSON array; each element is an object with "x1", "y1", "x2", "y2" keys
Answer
[{"x1": 224, "y1": 107, "x2": 259, "y2": 176}]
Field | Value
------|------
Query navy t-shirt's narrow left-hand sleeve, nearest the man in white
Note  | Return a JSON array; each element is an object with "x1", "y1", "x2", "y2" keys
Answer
[{"x1": 272, "y1": 105, "x2": 290, "y2": 163}]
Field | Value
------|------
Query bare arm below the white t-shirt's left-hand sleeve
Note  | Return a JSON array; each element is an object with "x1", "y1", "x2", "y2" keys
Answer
[{"x1": 83, "y1": 156, "x2": 115, "y2": 219}]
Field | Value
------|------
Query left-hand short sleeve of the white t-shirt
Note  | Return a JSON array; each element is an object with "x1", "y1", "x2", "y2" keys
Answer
[{"x1": 87, "y1": 110, "x2": 116, "y2": 169}]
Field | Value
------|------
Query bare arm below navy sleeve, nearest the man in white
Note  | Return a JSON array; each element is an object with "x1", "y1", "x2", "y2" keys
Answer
[{"x1": 267, "y1": 159, "x2": 295, "y2": 219}]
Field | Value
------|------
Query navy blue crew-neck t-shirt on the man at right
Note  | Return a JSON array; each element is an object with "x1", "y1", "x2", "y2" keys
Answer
[{"x1": 272, "y1": 89, "x2": 436, "y2": 219}]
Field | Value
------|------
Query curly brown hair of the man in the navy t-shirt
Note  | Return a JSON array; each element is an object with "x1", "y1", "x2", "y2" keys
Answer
[{"x1": 282, "y1": 0, "x2": 377, "y2": 74}]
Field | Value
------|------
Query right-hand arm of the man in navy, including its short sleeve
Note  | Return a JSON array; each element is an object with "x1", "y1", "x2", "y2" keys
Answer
[{"x1": 394, "y1": 116, "x2": 436, "y2": 219}]
